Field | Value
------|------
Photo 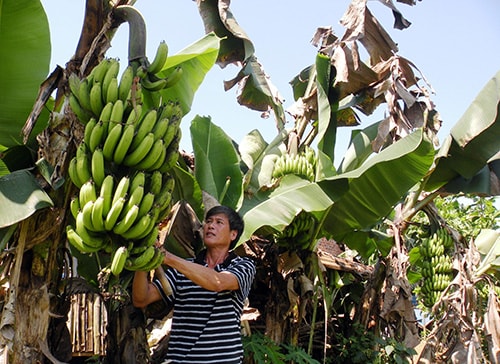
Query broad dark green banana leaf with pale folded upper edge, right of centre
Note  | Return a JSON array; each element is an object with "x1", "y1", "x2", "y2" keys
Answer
[{"x1": 319, "y1": 129, "x2": 434, "y2": 240}]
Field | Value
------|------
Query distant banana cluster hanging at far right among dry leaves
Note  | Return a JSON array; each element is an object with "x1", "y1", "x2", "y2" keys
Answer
[{"x1": 419, "y1": 228, "x2": 454, "y2": 307}]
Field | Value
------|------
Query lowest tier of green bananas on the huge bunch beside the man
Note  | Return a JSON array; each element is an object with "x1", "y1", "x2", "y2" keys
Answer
[{"x1": 67, "y1": 171, "x2": 175, "y2": 275}]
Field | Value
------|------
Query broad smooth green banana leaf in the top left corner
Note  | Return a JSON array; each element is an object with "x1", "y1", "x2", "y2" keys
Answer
[{"x1": 0, "y1": 0, "x2": 51, "y2": 147}]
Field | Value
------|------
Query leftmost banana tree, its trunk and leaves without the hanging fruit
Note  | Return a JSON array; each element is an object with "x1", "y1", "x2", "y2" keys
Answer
[{"x1": 0, "y1": 1, "x2": 220, "y2": 362}]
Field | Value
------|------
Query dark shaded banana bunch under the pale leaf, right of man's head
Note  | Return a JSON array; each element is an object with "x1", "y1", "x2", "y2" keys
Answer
[{"x1": 274, "y1": 210, "x2": 316, "y2": 250}]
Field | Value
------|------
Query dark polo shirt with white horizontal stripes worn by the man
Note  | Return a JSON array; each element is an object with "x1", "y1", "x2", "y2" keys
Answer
[{"x1": 153, "y1": 251, "x2": 255, "y2": 364}]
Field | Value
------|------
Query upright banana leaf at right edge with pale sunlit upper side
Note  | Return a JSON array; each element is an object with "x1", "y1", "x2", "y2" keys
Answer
[{"x1": 425, "y1": 71, "x2": 500, "y2": 193}]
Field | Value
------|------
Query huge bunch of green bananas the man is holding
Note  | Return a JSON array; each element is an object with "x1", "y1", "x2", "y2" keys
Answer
[{"x1": 67, "y1": 43, "x2": 183, "y2": 275}]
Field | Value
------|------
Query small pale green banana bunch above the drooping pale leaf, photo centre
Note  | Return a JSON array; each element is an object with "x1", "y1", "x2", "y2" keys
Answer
[{"x1": 272, "y1": 147, "x2": 316, "y2": 182}]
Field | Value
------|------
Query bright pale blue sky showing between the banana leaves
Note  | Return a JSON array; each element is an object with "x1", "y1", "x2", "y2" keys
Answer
[{"x1": 42, "y1": 0, "x2": 500, "y2": 165}]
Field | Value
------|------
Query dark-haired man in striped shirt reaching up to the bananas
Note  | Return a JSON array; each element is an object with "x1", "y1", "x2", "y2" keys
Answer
[{"x1": 132, "y1": 206, "x2": 255, "y2": 364}]
